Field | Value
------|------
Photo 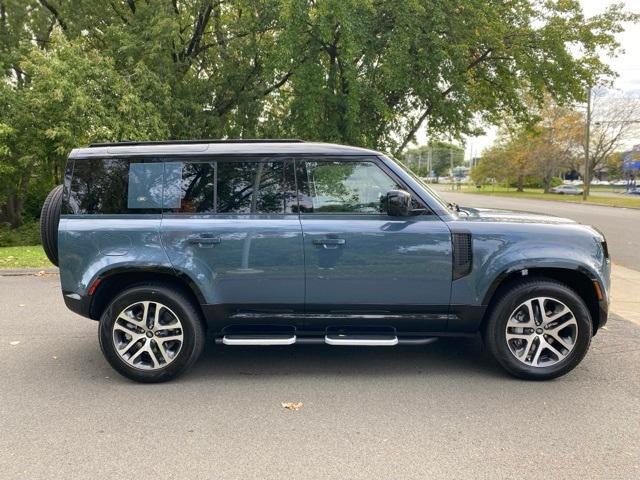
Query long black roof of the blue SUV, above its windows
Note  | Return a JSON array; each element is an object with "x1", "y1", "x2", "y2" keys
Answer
[{"x1": 69, "y1": 139, "x2": 380, "y2": 158}]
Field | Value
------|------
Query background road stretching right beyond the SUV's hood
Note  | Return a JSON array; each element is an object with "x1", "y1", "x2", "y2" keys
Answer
[{"x1": 437, "y1": 186, "x2": 640, "y2": 270}]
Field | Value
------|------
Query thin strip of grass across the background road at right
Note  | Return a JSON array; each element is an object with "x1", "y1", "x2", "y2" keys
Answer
[{"x1": 460, "y1": 185, "x2": 640, "y2": 208}]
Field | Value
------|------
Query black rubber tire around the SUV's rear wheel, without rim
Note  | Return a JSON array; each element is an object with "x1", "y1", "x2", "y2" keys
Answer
[{"x1": 98, "y1": 285, "x2": 205, "y2": 383}]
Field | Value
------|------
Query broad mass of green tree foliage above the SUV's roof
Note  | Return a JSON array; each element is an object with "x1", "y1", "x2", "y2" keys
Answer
[{"x1": 0, "y1": 0, "x2": 635, "y2": 223}]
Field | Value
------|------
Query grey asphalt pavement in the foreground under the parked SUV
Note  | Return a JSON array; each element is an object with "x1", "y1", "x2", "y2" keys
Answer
[{"x1": 0, "y1": 276, "x2": 640, "y2": 480}]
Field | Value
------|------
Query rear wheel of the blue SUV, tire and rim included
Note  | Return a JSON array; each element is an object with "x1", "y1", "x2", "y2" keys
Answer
[{"x1": 99, "y1": 285, "x2": 205, "y2": 383}]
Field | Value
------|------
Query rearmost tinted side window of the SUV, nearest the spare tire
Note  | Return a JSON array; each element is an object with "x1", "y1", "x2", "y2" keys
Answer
[{"x1": 67, "y1": 158, "x2": 163, "y2": 214}]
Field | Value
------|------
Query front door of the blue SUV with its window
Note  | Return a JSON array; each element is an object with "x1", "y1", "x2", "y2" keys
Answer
[{"x1": 298, "y1": 158, "x2": 451, "y2": 331}]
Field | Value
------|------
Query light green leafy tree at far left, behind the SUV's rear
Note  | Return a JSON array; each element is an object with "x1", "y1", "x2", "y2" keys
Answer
[{"x1": 0, "y1": 32, "x2": 168, "y2": 226}]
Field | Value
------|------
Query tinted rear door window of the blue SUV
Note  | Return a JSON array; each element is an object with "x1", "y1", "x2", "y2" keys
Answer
[{"x1": 171, "y1": 160, "x2": 297, "y2": 214}]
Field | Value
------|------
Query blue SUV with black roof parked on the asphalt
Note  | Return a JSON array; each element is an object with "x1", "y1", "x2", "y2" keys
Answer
[{"x1": 41, "y1": 140, "x2": 610, "y2": 382}]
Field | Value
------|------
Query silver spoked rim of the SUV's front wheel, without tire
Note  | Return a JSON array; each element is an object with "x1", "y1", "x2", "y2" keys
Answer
[{"x1": 505, "y1": 297, "x2": 578, "y2": 368}]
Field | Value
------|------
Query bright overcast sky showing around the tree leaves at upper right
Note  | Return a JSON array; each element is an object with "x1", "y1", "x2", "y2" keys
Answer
[{"x1": 420, "y1": 0, "x2": 640, "y2": 158}]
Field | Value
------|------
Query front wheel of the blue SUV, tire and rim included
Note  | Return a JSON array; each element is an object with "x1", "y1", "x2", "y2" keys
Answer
[{"x1": 484, "y1": 279, "x2": 593, "y2": 380}]
